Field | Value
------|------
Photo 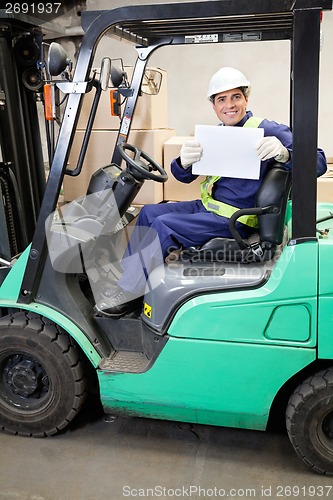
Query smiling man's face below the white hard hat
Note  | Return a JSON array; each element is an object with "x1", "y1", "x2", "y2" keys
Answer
[{"x1": 213, "y1": 89, "x2": 248, "y2": 125}]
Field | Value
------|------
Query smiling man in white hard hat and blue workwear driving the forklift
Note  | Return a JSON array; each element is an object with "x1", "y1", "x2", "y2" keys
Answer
[{"x1": 95, "y1": 67, "x2": 327, "y2": 318}]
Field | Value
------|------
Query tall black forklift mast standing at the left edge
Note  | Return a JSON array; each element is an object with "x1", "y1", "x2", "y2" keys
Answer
[{"x1": 0, "y1": 19, "x2": 45, "y2": 259}]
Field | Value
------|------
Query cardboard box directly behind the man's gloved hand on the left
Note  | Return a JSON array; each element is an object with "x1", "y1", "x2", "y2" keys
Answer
[{"x1": 163, "y1": 136, "x2": 205, "y2": 201}]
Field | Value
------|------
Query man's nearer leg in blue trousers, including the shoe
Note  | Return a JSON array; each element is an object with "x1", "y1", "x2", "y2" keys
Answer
[{"x1": 97, "y1": 202, "x2": 236, "y2": 315}]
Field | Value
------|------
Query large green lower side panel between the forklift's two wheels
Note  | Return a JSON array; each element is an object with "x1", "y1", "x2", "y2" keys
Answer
[{"x1": 98, "y1": 338, "x2": 316, "y2": 430}]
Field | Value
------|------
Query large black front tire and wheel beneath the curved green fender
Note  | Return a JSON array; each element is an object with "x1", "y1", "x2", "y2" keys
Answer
[{"x1": 0, "y1": 312, "x2": 87, "y2": 437}]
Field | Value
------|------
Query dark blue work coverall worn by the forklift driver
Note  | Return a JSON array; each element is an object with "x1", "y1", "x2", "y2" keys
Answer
[{"x1": 118, "y1": 111, "x2": 327, "y2": 296}]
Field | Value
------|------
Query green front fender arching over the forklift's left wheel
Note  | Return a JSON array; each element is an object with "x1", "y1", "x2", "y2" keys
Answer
[{"x1": 0, "y1": 247, "x2": 101, "y2": 368}]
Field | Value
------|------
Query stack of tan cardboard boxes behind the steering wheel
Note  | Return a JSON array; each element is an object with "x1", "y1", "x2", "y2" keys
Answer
[{"x1": 64, "y1": 67, "x2": 175, "y2": 205}]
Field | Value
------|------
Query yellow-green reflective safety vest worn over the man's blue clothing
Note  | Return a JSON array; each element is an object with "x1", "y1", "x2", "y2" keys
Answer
[{"x1": 200, "y1": 116, "x2": 262, "y2": 228}]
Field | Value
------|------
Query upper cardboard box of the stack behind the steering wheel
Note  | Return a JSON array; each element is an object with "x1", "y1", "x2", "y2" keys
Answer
[{"x1": 77, "y1": 67, "x2": 168, "y2": 130}]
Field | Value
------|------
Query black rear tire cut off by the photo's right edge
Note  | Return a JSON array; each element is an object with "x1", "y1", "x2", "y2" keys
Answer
[{"x1": 286, "y1": 367, "x2": 333, "y2": 476}]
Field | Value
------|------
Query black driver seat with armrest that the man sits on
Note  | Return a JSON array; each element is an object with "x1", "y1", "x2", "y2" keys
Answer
[{"x1": 180, "y1": 166, "x2": 291, "y2": 263}]
